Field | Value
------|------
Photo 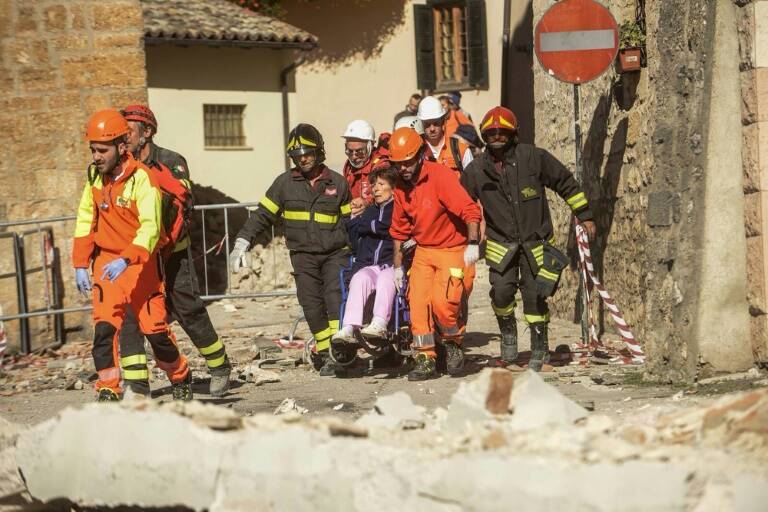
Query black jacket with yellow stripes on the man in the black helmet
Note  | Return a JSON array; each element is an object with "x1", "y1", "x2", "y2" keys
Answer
[{"x1": 237, "y1": 166, "x2": 352, "y2": 254}]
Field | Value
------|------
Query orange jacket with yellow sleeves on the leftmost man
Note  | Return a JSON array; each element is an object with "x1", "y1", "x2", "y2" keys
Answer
[{"x1": 72, "y1": 154, "x2": 162, "y2": 268}]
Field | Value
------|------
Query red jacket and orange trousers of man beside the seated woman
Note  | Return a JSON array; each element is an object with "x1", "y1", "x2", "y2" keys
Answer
[{"x1": 389, "y1": 161, "x2": 480, "y2": 357}]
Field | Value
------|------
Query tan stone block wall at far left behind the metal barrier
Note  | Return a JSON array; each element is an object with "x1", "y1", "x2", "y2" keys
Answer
[{"x1": 0, "y1": 0, "x2": 146, "y2": 346}]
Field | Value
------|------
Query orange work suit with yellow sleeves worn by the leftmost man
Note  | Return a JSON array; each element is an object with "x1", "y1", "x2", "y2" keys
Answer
[{"x1": 72, "y1": 155, "x2": 189, "y2": 393}]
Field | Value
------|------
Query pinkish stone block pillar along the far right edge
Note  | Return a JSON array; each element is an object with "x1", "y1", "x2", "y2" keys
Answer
[{"x1": 739, "y1": 0, "x2": 768, "y2": 363}]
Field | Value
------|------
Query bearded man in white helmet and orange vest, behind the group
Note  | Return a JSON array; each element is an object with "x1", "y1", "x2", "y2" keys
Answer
[{"x1": 417, "y1": 96, "x2": 473, "y2": 174}]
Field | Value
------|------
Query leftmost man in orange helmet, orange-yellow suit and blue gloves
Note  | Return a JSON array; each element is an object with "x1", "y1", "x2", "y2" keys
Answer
[{"x1": 72, "y1": 110, "x2": 192, "y2": 402}]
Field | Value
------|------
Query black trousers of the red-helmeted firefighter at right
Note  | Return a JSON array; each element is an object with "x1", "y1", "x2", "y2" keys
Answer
[{"x1": 489, "y1": 250, "x2": 549, "y2": 324}]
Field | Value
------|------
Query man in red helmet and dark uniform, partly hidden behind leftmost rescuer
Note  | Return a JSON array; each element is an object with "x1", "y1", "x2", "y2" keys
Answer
[{"x1": 120, "y1": 105, "x2": 232, "y2": 397}]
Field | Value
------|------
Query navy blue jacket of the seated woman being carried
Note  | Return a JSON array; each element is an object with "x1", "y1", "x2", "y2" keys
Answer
[{"x1": 347, "y1": 198, "x2": 395, "y2": 274}]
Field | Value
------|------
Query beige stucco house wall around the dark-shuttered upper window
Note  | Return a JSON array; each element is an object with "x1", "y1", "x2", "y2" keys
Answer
[{"x1": 284, "y1": 0, "x2": 526, "y2": 169}]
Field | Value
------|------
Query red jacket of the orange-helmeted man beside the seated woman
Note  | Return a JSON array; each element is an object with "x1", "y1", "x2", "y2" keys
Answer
[{"x1": 389, "y1": 161, "x2": 481, "y2": 249}]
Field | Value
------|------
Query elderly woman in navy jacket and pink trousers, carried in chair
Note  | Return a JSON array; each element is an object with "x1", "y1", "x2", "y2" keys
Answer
[{"x1": 333, "y1": 168, "x2": 397, "y2": 342}]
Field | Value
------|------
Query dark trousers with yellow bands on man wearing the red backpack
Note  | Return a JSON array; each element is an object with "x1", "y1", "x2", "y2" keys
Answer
[{"x1": 120, "y1": 244, "x2": 230, "y2": 392}]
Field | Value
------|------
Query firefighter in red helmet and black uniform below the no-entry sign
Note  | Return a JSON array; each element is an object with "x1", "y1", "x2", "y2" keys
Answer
[{"x1": 461, "y1": 107, "x2": 595, "y2": 371}]
